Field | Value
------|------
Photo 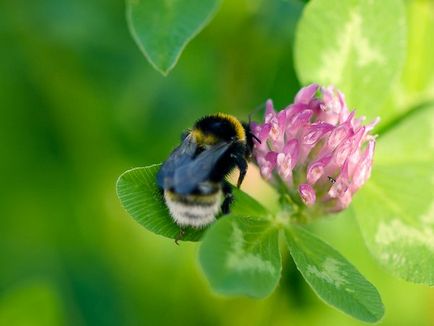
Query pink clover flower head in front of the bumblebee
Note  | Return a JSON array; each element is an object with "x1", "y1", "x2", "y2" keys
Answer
[{"x1": 251, "y1": 84, "x2": 379, "y2": 213}]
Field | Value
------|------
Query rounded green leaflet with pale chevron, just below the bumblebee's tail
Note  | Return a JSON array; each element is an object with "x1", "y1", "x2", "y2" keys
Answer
[{"x1": 199, "y1": 215, "x2": 281, "y2": 298}]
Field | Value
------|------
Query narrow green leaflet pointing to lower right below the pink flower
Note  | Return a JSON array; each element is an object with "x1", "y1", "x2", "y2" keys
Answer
[{"x1": 286, "y1": 225, "x2": 384, "y2": 322}]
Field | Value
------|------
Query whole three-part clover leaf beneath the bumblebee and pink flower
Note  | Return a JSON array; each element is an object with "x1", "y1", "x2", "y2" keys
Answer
[{"x1": 117, "y1": 164, "x2": 384, "y2": 322}]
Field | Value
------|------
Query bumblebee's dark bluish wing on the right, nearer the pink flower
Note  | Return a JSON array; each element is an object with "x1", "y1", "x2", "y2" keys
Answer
[{"x1": 174, "y1": 143, "x2": 231, "y2": 195}]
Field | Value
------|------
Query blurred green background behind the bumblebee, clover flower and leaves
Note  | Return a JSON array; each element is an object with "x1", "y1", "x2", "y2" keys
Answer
[{"x1": 0, "y1": 0, "x2": 434, "y2": 325}]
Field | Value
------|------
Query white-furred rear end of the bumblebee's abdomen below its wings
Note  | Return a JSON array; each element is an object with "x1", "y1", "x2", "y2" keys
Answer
[{"x1": 164, "y1": 189, "x2": 223, "y2": 228}]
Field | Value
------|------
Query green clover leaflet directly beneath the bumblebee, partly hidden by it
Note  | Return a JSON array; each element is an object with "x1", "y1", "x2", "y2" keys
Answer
[{"x1": 116, "y1": 164, "x2": 267, "y2": 241}]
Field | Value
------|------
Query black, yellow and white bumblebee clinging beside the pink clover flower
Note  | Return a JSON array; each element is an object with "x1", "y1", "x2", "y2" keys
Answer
[{"x1": 157, "y1": 113, "x2": 257, "y2": 233}]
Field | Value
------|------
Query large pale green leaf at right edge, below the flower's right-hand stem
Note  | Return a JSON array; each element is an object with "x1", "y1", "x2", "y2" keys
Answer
[{"x1": 353, "y1": 107, "x2": 434, "y2": 285}]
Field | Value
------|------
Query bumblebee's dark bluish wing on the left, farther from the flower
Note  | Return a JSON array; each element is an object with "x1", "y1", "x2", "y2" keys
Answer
[{"x1": 157, "y1": 137, "x2": 196, "y2": 189}]
